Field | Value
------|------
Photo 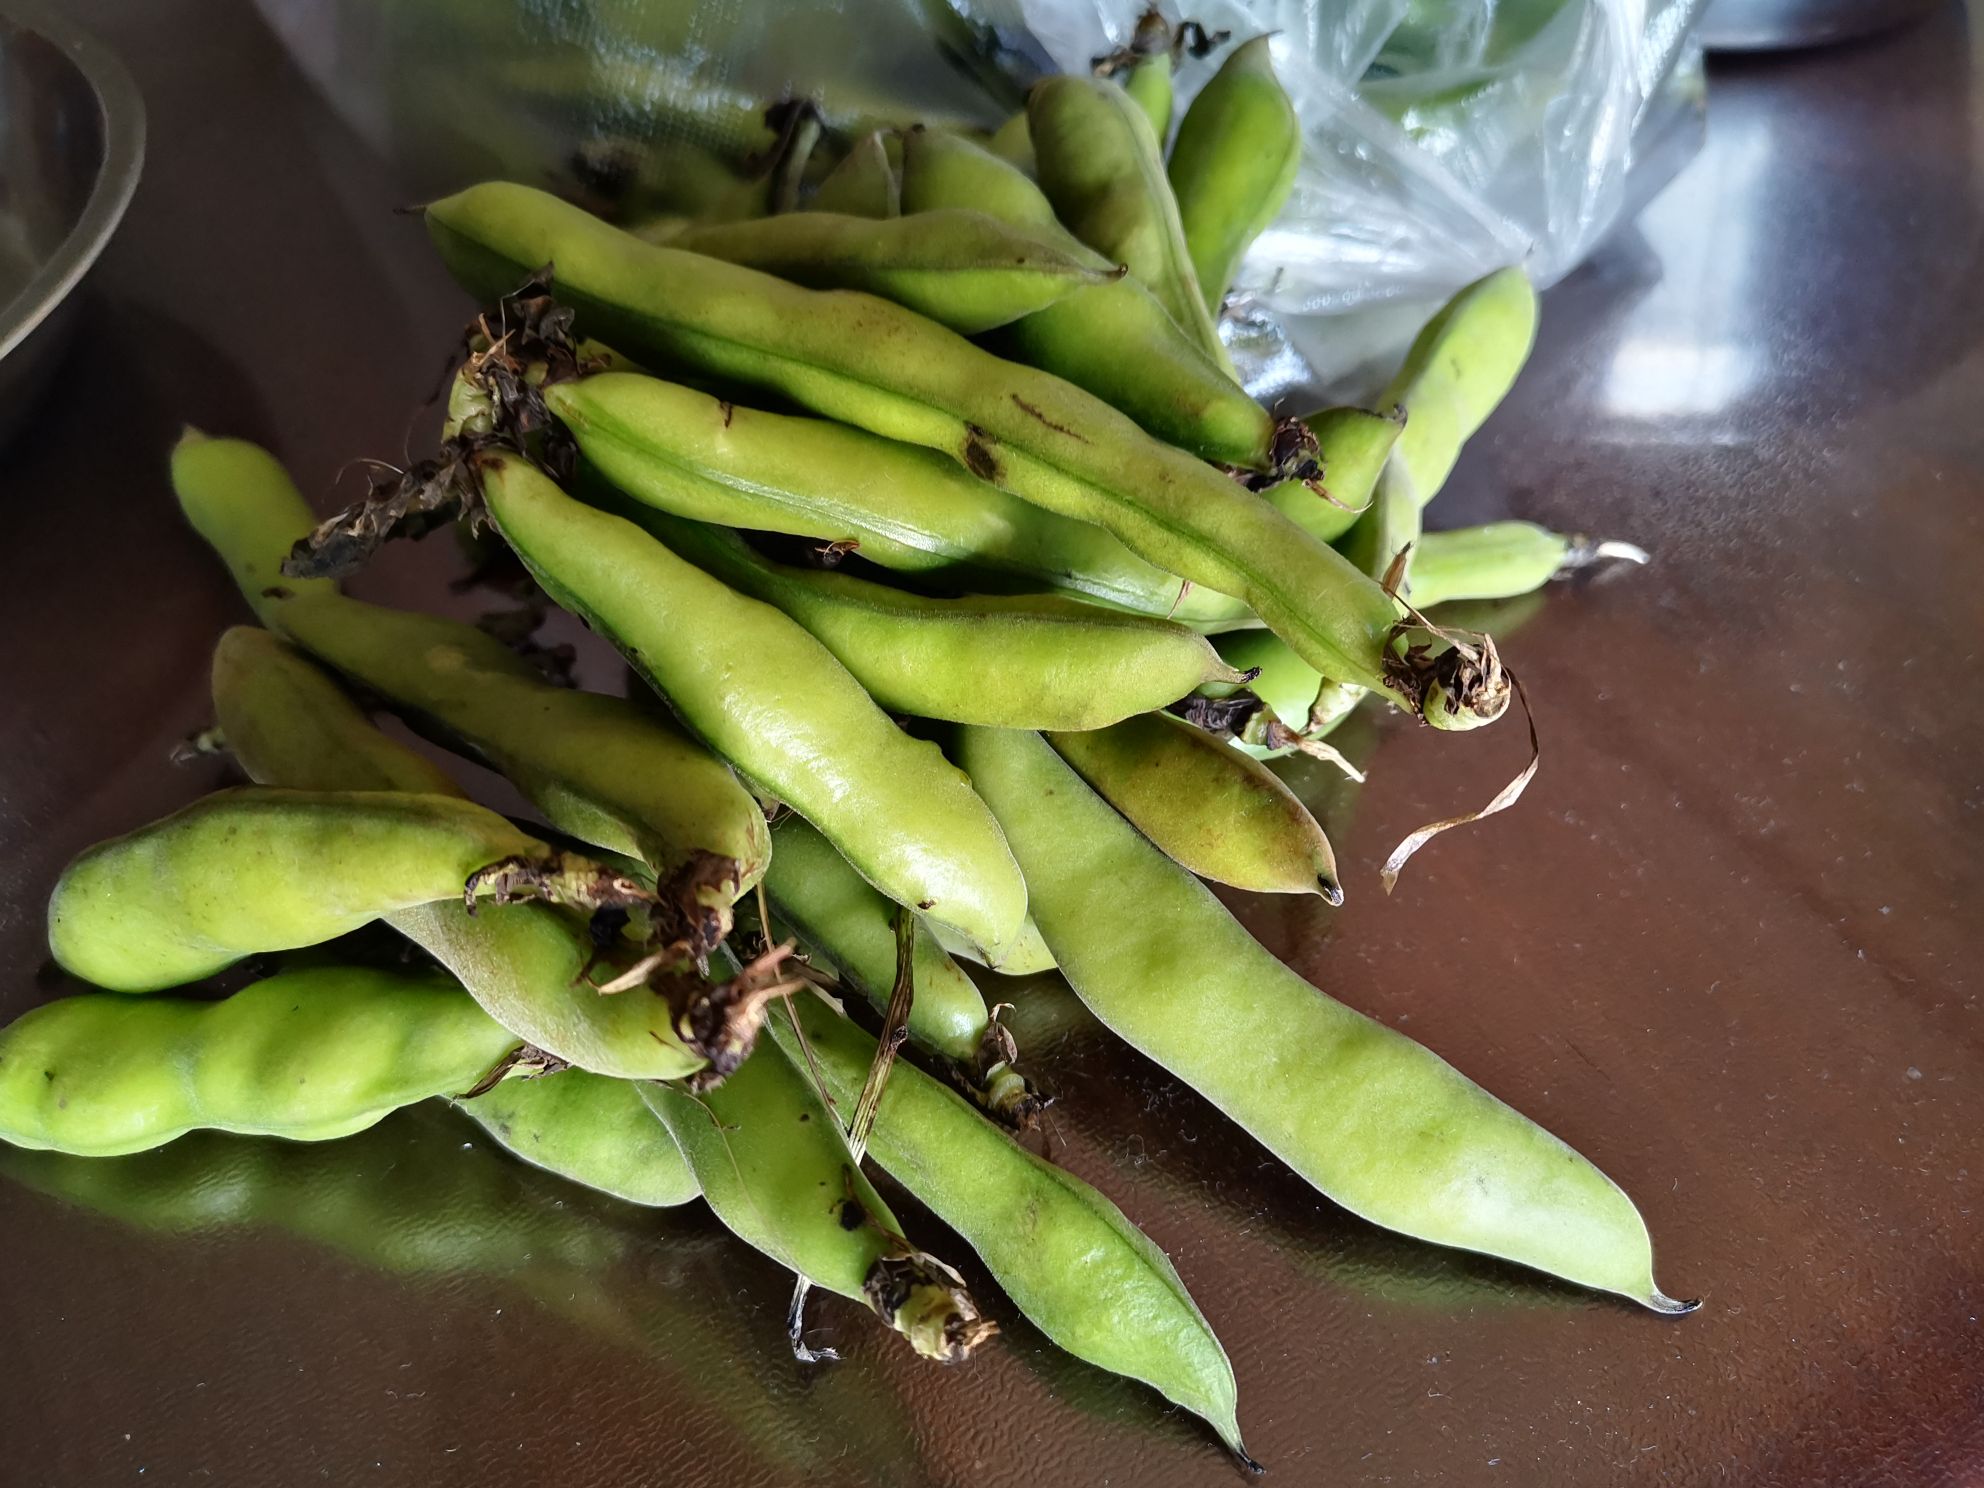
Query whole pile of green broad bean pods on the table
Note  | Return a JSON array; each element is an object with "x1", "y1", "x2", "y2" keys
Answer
[{"x1": 0, "y1": 28, "x2": 1688, "y2": 1452}]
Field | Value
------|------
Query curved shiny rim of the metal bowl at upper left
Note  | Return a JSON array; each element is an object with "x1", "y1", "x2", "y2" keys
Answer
[{"x1": 0, "y1": 0, "x2": 145, "y2": 357}]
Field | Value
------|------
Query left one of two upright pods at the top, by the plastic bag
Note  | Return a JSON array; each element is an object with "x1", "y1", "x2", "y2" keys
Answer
[{"x1": 1026, "y1": 73, "x2": 1224, "y2": 367}]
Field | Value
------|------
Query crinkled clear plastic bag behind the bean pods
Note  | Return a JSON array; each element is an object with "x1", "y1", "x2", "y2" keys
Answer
[{"x1": 248, "y1": 0, "x2": 1702, "y2": 401}]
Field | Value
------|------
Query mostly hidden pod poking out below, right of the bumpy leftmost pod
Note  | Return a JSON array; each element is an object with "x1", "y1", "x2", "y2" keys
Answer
[{"x1": 456, "y1": 1069, "x2": 702, "y2": 1208}]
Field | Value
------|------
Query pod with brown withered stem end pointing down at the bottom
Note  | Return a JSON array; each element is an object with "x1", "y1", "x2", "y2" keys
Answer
[{"x1": 641, "y1": 1050, "x2": 994, "y2": 1363}]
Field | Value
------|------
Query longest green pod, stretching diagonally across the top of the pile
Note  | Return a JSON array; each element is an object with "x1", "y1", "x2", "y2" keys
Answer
[{"x1": 427, "y1": 183, "x2": 1420, "y2": 706}]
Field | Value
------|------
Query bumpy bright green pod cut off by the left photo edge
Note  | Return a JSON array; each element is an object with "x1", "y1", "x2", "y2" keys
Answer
[{"x1": 0, "y1": 966, "x2": 518, "y2": 1157}]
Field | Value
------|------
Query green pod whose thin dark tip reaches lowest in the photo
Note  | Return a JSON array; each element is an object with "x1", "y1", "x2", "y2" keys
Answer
[{"x1": 772, "y1": 998, "x2": 1242, "y2": 1452}]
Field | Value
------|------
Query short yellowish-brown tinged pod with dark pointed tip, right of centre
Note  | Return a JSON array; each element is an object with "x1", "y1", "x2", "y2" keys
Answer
[{"x1": 1048, "y1": 712, "x2": 1343, "y2": 905}]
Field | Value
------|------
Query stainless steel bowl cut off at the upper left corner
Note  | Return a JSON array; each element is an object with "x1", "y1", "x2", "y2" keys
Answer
[{"x1": 0, "y1": 0, "x2": 145, "y2": 440}]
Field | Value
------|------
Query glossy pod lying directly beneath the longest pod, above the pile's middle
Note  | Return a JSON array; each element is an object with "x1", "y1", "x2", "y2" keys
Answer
[{"x1": 544, "y1": 373, "x2": 1248, "y2": 625}]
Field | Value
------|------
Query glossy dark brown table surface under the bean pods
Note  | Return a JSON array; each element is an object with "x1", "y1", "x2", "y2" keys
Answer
[{"x1": 0, "y1": 0, "x2": 1984, "y2": 1488}]
